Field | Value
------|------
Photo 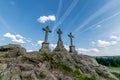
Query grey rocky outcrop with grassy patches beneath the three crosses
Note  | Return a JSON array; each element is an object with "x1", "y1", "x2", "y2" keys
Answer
[{"x1": 0, "y1": 45, "x2": 119, "y2": 80}]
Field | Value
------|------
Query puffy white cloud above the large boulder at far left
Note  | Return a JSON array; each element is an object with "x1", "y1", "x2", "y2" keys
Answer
[{"x1": 3, "y1": 33, "x2": 26, "y2": 43}]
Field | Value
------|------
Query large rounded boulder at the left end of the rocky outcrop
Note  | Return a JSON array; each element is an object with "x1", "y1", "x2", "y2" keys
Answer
[{"x1": 0, "y1": 44, "x2": 26, "y2": 58}]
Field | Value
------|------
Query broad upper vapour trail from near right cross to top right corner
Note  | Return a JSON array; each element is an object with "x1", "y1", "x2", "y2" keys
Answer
[{"x1": 74, "y1": 0, "x2": 120, "y2": 32}]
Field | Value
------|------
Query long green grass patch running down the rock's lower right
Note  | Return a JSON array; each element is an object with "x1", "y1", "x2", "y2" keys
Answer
[{"x1": 51, "y1": 63, "x2": 97, "y2": 80}]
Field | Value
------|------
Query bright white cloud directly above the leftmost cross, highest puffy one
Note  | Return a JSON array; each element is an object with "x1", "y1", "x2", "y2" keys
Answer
[{"x1": 38, "y1": 15, "x2": 56, "y2": 23}]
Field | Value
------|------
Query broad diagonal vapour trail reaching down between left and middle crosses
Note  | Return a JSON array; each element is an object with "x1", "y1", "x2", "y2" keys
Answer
[{"x1": 52, "y1": 0, "x2": 79, "y2": 32}]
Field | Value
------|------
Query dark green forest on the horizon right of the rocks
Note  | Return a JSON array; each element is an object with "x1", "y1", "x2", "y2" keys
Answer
[{"x1": 96, "y1": 57, "x2": 120, "y2": 67}]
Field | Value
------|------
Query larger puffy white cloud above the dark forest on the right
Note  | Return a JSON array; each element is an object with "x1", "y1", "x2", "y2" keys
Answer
[{"x1": 98, "y1": 40, "x2": 117, "y2": 47}]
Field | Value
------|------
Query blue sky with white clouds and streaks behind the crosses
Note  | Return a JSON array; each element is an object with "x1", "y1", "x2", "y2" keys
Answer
[{"x1": 0, "y1": 0, "x2": 120, "y2": 56}]
